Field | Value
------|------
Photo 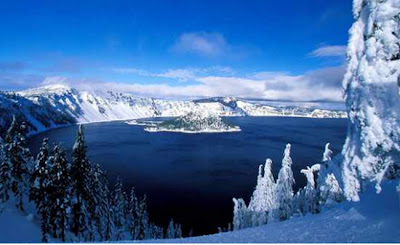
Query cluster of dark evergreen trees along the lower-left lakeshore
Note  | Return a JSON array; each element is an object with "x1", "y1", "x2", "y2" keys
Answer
[{"x1": 0, "y1": 117, "x2": 177, "y2": 242}]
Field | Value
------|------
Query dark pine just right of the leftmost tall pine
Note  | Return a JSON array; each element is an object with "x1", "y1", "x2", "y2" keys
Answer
[{"x1": 29, "y1": 138, "x2": 51, "y2": 242}]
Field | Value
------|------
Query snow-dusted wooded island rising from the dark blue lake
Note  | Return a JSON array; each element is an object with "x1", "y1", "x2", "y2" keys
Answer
[{"x1": 144, "y1": 111, "x2": 241, "y2": 133}]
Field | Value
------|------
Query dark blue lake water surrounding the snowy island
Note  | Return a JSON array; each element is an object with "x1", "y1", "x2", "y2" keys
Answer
[{"x1": 30, "y1": 117, "x2": 347, "y2": 235}]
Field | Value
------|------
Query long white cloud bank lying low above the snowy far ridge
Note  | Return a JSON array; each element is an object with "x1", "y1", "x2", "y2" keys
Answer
[{"x1": 39, "y1": 66, "x2": 344, "y2": 101}]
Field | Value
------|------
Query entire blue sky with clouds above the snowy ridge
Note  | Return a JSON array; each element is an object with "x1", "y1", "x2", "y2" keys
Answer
[{"x1": 0, "y1": 0, "x2": 352, "y2": 100}]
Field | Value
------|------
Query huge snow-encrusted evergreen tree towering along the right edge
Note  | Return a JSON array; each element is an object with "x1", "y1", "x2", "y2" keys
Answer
[{"x1": 342, "y1": 0, "x2": 400, "y2": 201}]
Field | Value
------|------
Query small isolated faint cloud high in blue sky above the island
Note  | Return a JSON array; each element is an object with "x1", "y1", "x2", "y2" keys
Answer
[{"x1": 172, "y1": 32, "x2": 230, "y2": 57}]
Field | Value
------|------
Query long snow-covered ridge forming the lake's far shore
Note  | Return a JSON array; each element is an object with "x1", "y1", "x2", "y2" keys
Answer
[{"x1": 0, "y1": 85, "x2": 346, "y2": 136}]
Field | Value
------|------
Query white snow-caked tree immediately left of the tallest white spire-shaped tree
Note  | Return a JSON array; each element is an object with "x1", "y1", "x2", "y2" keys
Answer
[{"x1": 249, "y1": 158, "x2": 275, "y2": 226}]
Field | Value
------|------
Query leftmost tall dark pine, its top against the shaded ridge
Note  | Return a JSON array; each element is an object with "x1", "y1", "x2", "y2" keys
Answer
[{"x1": 3, "y1": 116, "x2": 32, "y2": 211}]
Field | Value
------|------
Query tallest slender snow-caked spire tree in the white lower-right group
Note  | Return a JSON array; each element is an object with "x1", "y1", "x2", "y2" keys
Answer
[{"x1": 273, "y1": 144, "x2": 295, "y2": 220}]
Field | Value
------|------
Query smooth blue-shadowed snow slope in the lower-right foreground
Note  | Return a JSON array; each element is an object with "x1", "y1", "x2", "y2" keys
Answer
[{"x1": 137, "y1": 181, "x2": 400, "y2": 243}]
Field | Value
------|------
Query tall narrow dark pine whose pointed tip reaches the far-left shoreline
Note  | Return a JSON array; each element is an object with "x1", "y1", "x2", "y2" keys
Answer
[{"x1": 71, "y1": 125, "x2": 91, "y2": 239}]
